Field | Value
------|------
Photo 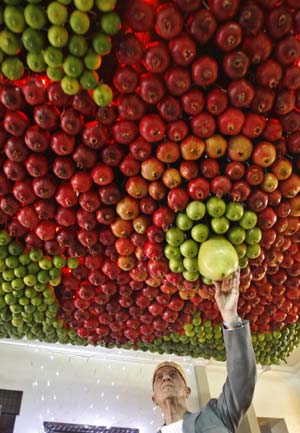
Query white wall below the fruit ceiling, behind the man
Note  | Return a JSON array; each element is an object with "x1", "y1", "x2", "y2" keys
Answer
[{"x1": 0, "y1": 341, "x2": 300, "y2": 433}]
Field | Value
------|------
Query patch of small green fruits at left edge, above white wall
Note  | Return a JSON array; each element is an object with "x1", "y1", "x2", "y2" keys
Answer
[{"x1": 0, "y1": 231, "x2": 78, "y2": 341}]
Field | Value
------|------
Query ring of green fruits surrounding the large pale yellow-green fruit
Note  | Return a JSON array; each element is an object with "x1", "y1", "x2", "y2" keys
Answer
[{"x1": 164, "y1": 196, "x2": 262, "y2": 284}]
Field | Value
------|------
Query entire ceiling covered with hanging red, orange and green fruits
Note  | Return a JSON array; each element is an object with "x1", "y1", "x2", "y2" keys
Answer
[{"x1": 0, "y1": 0, "x2": 300, "y2": 364}]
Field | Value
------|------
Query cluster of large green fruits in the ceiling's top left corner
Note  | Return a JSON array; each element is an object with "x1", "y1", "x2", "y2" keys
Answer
[{"x1": 0, "y1": 0, "x2": 121, "y2": 106}]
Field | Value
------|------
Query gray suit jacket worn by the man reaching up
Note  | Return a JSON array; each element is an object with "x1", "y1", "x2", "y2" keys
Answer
[{"x1": 161, "y1": 320, "x2": 256, "y2": 433}]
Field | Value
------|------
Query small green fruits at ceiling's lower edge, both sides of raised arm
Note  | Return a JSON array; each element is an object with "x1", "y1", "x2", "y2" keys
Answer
[{"x1": 139, "y1": 312, "x2": 300, "y2": 365}]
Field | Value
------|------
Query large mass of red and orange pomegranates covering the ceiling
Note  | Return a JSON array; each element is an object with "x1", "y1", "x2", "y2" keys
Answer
[{"x1": 0, "y1": 0, "x2": 300, "y2": 358}]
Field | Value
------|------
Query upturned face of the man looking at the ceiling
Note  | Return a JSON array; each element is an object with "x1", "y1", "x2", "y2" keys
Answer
[{"x1": 152, "y1": 366, "x2": 191, "y2": 406}]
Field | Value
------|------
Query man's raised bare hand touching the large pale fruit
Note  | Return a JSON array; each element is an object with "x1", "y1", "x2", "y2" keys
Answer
[{"x1": 213, "y1": 269, "x2": 240, "y2": 323}]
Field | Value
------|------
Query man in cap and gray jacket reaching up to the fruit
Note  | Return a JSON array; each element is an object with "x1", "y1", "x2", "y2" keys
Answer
[{"x1": 152, "y1": 271, "x2": 256, "y2": 433}]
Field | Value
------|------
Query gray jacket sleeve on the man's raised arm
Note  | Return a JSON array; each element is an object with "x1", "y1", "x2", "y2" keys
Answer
[{"x1": 211, "y1": 320, "x2": 256, "y2": 432}]
